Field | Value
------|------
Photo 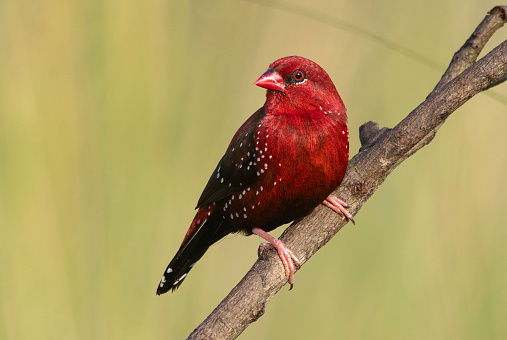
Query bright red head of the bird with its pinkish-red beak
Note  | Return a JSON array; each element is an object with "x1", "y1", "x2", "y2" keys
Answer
[{"x1": 255, "y1": 56, "x2": 346, "y2": 119}]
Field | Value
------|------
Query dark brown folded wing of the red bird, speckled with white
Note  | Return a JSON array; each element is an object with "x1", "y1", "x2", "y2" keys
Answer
[{"x1": 197, "y1": 107, "x2": 264, "y2": 208}]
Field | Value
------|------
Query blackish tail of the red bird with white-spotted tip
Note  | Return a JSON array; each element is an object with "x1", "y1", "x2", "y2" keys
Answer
[{"x1": 157, "y1": 205, "x2": 233, "y2": 295}]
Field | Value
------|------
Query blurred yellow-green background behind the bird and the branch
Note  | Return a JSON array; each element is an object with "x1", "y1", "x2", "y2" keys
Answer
[{"x1": 0, "y1": 0, "x2": 507, "y2": 339}]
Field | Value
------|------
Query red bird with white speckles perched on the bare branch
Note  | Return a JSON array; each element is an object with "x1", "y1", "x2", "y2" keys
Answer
[{"x1": 157, "y1": 56, "x2": 353, "y2": 295}]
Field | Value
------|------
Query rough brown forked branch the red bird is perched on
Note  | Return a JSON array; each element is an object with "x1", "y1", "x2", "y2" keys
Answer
[{"x1": 189, "y1": 6, "x2": 507, "y2": 339}]
